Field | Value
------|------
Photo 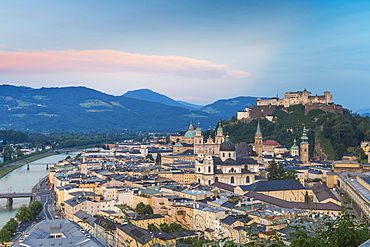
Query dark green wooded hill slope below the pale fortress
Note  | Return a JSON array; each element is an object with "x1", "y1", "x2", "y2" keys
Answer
[{"x1": 224, "y1": 105, "x2": 370, "y2": 160}]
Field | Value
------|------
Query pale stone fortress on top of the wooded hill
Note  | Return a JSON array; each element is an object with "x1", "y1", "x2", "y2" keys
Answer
[{"x1": 237, "y1": 89, "x2": 343, "y2": 122}]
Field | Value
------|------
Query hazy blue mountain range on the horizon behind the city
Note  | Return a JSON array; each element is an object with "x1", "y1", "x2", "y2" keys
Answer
[{"x1": 0, "y1": 85, "x2": 257, "y2": 132}]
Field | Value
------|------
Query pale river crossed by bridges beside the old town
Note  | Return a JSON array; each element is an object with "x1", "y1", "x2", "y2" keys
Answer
[{"x1": 0, "y1": 152, "x2": 79, "y2": 229}]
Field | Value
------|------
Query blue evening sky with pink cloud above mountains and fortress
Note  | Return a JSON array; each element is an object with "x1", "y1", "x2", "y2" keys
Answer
[{"x1": 0, "y1": 0, "x2": 370, "y2": 111}]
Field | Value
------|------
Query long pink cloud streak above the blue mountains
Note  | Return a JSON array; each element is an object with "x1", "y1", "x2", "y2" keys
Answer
[{"x1": 0, "y1": 50, "x2": 250, "y2": 78}]
